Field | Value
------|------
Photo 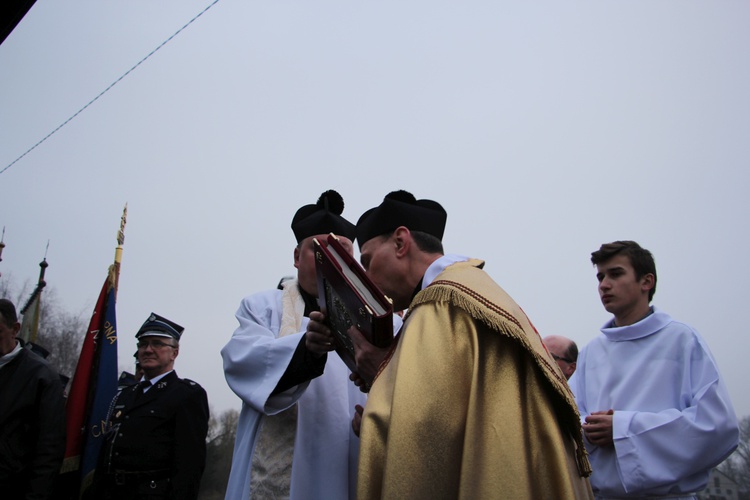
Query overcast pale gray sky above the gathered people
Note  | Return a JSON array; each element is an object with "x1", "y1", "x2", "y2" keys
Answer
[{"x1": 0, "y1": 0, "x2": 750, "y2": 416}]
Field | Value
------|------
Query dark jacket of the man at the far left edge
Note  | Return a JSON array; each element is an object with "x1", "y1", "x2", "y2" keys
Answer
[{"x1": 0, "y1": 349, "x2": 65, "y2": 500}]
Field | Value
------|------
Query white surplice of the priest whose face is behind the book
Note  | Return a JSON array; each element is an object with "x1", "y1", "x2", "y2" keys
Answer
[{"x1": 221, "y1": 281, "x2": 366, "y2": 500}]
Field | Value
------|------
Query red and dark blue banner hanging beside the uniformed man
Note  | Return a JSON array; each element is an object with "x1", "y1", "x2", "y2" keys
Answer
[{"x1": 61, "y1": 266, "x2": 117, "y2": 497}]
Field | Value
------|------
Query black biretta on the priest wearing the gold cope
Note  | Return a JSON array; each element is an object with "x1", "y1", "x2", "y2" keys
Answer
[{"x1": 357, "y1": 190, "x2": 448, "y2": 248}]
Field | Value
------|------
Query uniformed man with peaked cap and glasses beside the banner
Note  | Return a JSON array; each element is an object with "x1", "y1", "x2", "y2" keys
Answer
[{"x1": 94, "y1": 313, "x2": 209, "y2": 500}]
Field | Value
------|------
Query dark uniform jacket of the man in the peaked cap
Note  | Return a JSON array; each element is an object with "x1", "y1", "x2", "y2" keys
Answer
[{"x1": 97, "y1": 371, "x2": 208, "y2": 500}]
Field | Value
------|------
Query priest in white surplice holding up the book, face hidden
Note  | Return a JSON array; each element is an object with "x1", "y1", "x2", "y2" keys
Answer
[{"x1": 221, "y1": 190, "x2": 374, "y2": 500}]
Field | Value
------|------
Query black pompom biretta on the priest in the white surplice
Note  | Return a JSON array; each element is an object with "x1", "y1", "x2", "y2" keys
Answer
[{"x1": 292, "y1": 189, "x2": 357, "y2": 243}]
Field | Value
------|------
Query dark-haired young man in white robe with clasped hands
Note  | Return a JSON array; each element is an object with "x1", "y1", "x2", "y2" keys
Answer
[{"x1": 570, "y1": 241, "x2": 738, "y2": 499}]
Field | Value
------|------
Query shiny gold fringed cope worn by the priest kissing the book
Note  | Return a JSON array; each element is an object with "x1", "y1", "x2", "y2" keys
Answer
[{"x1": 358, "y1": 260, "x2": 593, "y2": 500}]
